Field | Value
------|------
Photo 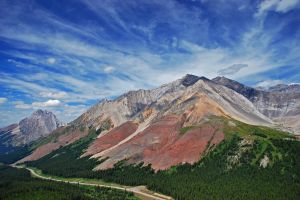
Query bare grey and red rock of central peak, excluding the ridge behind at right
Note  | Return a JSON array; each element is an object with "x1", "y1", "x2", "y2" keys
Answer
[{"x1": 22, "y1": 74, "x2": 286, "y2": 170}]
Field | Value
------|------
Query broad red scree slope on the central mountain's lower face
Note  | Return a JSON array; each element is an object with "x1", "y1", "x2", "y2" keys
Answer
[{"x1": 94, "y1": 115, "x2": 224, "y2": 170}]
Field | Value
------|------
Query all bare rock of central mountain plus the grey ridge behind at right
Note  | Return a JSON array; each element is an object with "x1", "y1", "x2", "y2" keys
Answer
[{"x1": 1, "y1": 74, "x2": 300, "y2": 170}]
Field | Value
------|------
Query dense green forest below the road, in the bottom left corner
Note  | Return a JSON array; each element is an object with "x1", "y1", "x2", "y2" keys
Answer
[{"x1": 0, "y1": 165, "x2": 137, "y2": 200}]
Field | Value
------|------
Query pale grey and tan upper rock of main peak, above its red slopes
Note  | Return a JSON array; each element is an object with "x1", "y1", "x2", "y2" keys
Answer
[{"x1": 73, "y1": 74, "x2": 271, "y2": 128}]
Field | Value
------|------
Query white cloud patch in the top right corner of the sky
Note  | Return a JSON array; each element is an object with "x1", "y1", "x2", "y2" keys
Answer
[{"x1": 256, "y1": 0, "x2": 300, "y2": 16}]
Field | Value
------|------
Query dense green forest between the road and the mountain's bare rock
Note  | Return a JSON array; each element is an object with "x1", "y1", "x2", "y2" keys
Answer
[{"x1": 27, "y1": 120, "x2": 300, "y2": 200}]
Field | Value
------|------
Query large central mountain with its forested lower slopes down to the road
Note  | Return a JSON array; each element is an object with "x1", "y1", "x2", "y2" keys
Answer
[{"x1": 14, "y1": 75, "x2": 300, "y2": 200}]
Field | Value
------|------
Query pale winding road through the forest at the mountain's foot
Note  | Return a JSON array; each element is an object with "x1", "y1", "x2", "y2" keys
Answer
[{"x1": 12, "y1": 165, "x2": 173, "y2": 200}]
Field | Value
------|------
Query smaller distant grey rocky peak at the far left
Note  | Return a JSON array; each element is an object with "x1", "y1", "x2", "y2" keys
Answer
[{"x1": 0, "y1": 110, "x2": 63, "y2": 153}]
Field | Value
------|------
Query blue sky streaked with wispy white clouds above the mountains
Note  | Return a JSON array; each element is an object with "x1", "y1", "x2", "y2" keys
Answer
[{"x1": 0, "y1": 0, "x2": 300, "y2": 127}]
